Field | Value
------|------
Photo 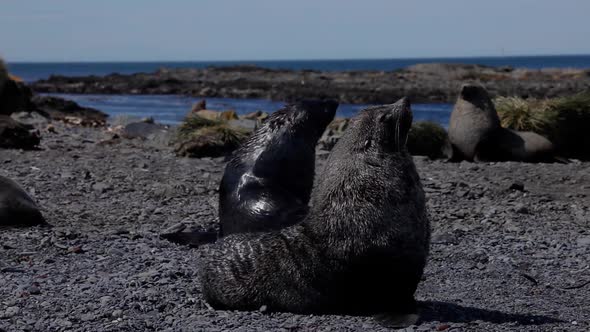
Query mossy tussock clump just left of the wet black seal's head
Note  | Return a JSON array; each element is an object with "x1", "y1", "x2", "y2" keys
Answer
[{"x1": 175, "y1": 115, "x2": 249, "y2": 158}]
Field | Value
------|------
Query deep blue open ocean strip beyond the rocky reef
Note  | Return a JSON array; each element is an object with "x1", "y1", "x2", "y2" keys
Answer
[{"x1": 8, "y1": 55, "x2": 590, "y2": 82}]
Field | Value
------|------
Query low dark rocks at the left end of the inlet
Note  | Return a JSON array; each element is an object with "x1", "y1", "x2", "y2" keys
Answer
[{"x1": 32, "y1": 96, "x2": 108, "y2": 127}]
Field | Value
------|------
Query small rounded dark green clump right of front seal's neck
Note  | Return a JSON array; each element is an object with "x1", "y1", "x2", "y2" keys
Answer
[{"x1": 407, "y1": 121, "x2": 448, "y2": 159}]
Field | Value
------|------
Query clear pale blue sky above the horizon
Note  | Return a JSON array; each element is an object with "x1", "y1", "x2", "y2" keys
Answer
[{"x1": 0, "y1": 0, "x2": 590, "y2": 61}]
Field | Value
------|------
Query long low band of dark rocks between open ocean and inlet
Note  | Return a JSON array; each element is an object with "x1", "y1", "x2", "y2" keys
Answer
[{"x1": 31, "y1": 64, "x2": 590, "y2": 104}]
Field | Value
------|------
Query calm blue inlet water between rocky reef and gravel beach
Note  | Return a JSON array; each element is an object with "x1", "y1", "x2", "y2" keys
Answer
[{"x1": 48, "y1": 94, "x2": 452, "y2": 127}]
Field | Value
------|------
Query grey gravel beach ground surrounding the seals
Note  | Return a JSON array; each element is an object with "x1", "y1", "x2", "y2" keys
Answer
[{"x1": 0, "y1": 125, "x2": 590, "y2": 331}]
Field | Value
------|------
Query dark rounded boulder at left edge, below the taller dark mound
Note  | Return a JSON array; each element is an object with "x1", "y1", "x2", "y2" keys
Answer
[{"x1": 0, "y1": 115, "x2": 41, "y2": 150}]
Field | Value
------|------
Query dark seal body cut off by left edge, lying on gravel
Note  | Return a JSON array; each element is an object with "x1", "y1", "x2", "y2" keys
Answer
[{"x1": 0, "y1": 175, "x2": 47, "y2": 226}]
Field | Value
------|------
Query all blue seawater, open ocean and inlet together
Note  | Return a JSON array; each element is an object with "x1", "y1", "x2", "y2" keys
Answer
[{"x1": 8, "y1": 55, "x2": 590, "y2": 127}]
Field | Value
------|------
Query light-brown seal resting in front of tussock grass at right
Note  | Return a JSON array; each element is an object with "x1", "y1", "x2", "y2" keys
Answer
[{"x1": 449, "y1": 84, "x2": 557, "y2": 162}]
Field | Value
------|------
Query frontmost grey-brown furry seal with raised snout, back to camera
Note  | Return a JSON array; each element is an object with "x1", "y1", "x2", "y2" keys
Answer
[{"x1": 200, "y1": 98, "x2": 430, "y2": 326}]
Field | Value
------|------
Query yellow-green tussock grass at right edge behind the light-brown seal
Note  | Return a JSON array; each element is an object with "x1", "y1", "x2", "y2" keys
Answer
[{"x1": 494, "y1": 91, "x2": 590, "y2": 160}]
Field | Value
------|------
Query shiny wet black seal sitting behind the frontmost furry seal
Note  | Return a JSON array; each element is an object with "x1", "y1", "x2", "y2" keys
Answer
[{"x1": 163, "y1": 100, "x2": 338, "y2": 247}]
